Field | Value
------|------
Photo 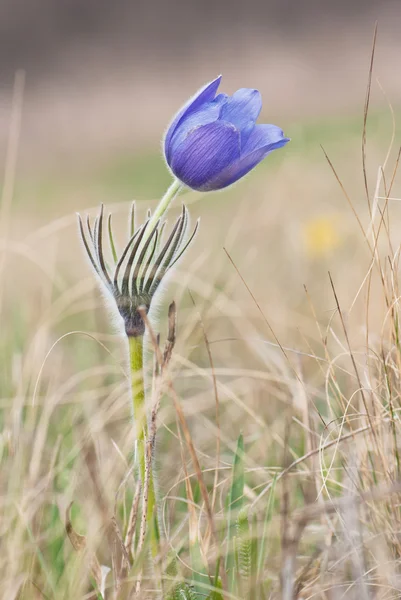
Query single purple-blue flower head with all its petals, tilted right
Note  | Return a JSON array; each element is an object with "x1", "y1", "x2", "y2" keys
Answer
[{"x1": 164, "y1": 75, "x2": 289, "y2": 191}]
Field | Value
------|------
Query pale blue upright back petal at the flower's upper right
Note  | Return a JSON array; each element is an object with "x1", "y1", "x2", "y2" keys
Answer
[{"x1": 220, "y1": 88, "x2": 262, "y2": 147}]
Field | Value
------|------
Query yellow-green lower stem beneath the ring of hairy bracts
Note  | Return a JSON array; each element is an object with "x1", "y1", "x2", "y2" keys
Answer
[{"x1": 128, "y1": 336, "x2": 159, "y2": 556}]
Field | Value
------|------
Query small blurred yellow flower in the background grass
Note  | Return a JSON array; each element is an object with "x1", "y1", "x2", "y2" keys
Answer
[{"x1": 303, "y1": 215, "x2": 341, "y2": 258}]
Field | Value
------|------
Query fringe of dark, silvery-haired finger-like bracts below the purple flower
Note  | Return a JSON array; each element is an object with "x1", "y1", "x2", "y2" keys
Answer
[{"x1": 78, "y1": 204, "x2": 198, "y2": 337}]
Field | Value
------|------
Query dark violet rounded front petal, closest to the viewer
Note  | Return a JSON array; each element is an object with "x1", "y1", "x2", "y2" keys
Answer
[{"x1": 170, "y1": 121, "x2": 240, "y2": 191}]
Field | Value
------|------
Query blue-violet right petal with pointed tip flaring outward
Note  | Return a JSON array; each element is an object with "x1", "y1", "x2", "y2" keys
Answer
[{"x1": 203, "y1": 125, "x2": 290, "y2": 190}]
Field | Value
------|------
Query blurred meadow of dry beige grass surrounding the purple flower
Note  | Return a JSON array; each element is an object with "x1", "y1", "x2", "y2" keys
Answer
[{"x1": 0, "y1": 0, "x2": 401, "y2": 600}]
